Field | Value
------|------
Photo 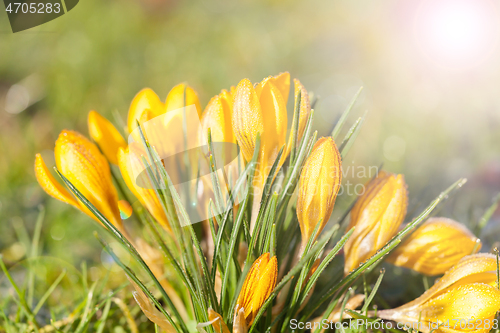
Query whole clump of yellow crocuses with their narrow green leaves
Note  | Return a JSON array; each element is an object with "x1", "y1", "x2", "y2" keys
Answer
[{"x1": 35, "y1": 72, "x2": 500, "y2": 333}]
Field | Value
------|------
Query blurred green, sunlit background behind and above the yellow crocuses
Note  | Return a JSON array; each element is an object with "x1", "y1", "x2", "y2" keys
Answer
[{"x1": 0, "y1": 0, "x2": 500, "y2": 322}]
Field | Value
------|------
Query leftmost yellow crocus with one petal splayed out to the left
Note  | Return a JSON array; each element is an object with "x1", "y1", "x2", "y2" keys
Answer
[{"x1": 35, "y1": 130, "x2": 124, "y2": 232}]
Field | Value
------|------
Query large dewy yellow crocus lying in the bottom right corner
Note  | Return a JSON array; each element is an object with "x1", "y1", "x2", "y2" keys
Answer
[{"x1": 377, "y1": 253, "x2": 500, "y2": 333}]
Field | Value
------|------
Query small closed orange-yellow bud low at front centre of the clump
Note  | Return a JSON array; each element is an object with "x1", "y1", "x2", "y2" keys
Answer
[{"x1": 234, "y1": 253, "x2": 278, "y2": 326}]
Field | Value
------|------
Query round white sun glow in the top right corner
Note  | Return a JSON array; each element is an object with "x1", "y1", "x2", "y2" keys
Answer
[{"x1": 415, "y1": 0, "x2": 500, "y2": 69}]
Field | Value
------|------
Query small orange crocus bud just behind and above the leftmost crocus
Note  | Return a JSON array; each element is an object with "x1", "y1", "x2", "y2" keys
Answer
[{"x1": 88, "y1": 111, "x2": 127, "y2": 165}]
